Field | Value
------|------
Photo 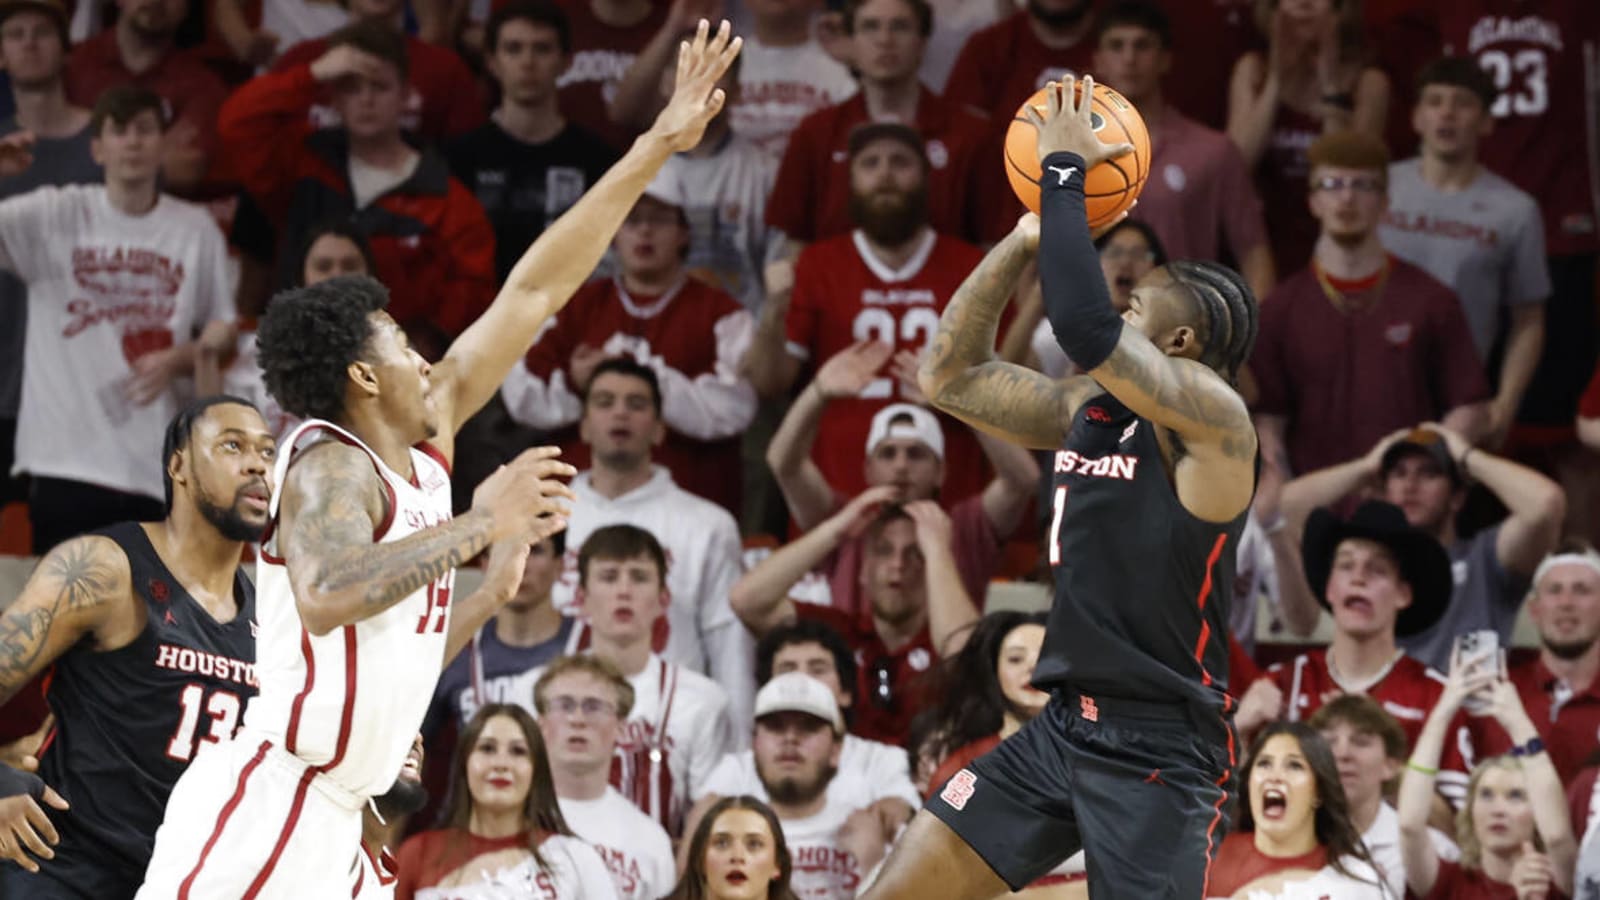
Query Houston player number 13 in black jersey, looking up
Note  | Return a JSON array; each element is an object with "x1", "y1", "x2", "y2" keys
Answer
[{"x1": 0, "y1": 397, "x2": 277, "y2": 900}]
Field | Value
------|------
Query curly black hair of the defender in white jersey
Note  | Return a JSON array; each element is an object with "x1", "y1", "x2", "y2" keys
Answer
[{"x1": 256, "y1": 275, "x2": 389, "y2": 420}]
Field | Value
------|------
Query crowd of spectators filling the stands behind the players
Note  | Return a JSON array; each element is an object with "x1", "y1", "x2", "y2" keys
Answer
[{"x1": 0, "y1": 0, "x2": 1600, "y2": 900}]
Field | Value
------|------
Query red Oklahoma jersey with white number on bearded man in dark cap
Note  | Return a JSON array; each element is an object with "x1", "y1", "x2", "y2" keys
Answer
[{"x1": 787, "y1": 232, "x2": 1003, "y2": 498}]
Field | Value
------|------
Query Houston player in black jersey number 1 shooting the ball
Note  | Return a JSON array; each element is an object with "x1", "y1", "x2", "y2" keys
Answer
[{"x1": 867, "y1": 78, "x2": 1258, "y2": 900}]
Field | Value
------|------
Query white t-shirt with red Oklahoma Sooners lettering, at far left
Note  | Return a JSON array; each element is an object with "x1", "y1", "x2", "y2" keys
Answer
[{"x1": 0, "y1": 184, "x2": 235, "y2": 498}]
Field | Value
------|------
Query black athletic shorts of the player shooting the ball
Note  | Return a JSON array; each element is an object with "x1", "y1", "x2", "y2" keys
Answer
[{"x1": 928, "y1": 692, "x2": 1235, "y2": 900}]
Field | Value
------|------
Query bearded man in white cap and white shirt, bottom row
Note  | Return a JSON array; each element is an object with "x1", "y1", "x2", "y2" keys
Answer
[{"x1": 752, "y1": 673, "x2": 894, "y2": 900}]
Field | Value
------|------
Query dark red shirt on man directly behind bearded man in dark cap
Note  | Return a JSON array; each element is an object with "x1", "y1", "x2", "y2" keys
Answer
[{"x1": 766, "y1": 88, "x2": 994, "y2": 243}]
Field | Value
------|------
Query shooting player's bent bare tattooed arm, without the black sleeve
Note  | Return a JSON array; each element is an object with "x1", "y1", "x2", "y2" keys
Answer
[{"x1": 917, "y1": 224, "x2": 1098, "y2": 450}]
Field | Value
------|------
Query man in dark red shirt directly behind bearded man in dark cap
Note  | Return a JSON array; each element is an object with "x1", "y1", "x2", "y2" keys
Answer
[{"x1": 766, "y1": 0, "x2": 995, "y2": 242}]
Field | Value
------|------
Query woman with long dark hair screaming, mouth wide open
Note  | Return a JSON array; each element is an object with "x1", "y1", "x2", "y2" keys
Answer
[{"x1": 1210, "y1": 722, "x2": 1387, "y2": 900}]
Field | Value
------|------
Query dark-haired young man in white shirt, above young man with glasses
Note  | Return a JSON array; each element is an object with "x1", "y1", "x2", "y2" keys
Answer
[{"x1": 550, "y1": 525, "x2": 731, "y2": 834}]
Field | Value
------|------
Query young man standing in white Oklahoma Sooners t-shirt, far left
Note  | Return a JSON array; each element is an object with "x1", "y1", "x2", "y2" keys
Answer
[{"x1": 0, "y1": 86, "x2": 235, "y2": 552}]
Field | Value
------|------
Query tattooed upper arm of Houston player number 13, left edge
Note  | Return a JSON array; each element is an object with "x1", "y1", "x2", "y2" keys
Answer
[{"x1": 0, "y1": 536, "x2": 132, "y2": 703}]
